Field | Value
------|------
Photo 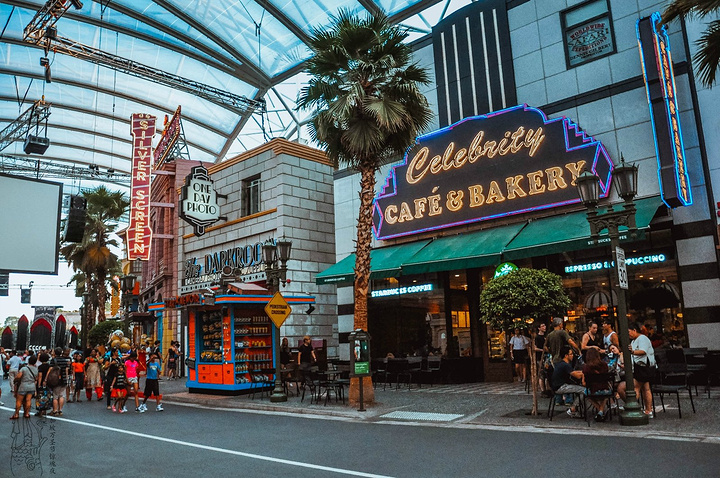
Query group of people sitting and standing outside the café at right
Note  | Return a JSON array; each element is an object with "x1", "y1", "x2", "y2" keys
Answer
[{"x1": 508, "y1": 317, "x2": 662, "y2": 421}]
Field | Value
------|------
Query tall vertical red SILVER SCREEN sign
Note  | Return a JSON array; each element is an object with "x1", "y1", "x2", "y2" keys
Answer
[{"x1": 127, "y1": 113, "x2": 155, "y2": 261}]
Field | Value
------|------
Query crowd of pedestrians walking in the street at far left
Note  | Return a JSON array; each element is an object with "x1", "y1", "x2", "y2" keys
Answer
[{"x1": 0, "y1": 341, "x2": 170, "y2": 420}]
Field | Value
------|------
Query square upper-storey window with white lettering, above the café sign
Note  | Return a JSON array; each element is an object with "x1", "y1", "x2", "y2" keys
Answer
[{"x1": 560, "y1": 0, "x2": 615, "y2": 68}]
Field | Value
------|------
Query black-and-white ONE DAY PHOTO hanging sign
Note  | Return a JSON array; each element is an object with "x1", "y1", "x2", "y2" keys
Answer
[{"x1": 180, "y1": 166, "x2": 220, "y2": 237}]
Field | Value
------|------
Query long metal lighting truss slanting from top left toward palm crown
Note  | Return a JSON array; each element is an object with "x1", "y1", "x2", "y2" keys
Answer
[{"x1": 23, "y1": 0, "x2": 265, "y2": 115}]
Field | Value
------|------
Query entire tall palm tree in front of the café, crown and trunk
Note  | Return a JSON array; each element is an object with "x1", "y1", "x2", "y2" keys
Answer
[{"x1": 297, "y1": 10, "x2": 432, "y2": 404}]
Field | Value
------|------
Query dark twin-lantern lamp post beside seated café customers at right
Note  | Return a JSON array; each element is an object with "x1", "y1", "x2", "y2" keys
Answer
[{"x1": 575, "y1": 157, "x2": 649, "y2": 426}]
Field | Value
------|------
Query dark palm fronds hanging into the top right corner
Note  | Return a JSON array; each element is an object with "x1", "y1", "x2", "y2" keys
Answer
[{"x1": 662, "y1": 0, "x2": 720, "y2": 88}]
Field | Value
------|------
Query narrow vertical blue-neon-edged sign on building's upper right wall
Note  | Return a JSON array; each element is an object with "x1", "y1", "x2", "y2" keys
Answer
[{"x1": 636, "y1": 12, "x2": 692, "y2": 207}]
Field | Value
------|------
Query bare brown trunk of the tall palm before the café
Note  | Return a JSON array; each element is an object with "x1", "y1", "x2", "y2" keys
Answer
[{"x1": 349, "y1": 166, "x2": 375, "y2": 405}]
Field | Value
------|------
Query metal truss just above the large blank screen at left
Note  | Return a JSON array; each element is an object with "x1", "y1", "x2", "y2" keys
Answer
[{"x1": 0, "y1": 154, "x2": 130, "y2": 188}]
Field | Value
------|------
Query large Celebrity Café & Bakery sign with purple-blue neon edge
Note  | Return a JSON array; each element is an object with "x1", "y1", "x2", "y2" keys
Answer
[{"x1": 373, "y1": 105, "x2": 613, "y2": 239}]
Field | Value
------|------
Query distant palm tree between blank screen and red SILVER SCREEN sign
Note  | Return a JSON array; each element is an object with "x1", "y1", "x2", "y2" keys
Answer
[{"x1": 60, "y1": 186, "x2": 129, "y2": 343}]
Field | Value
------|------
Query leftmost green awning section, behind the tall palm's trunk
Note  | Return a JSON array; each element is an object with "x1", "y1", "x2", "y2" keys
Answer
[{"x1": 315, "y1": 240, "x2": 430, "y2": 285}]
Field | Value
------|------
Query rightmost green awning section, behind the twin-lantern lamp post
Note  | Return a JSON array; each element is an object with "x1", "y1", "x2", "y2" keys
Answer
[{"x1": 503, "y1": 197, "x2": 663, "y2": 260}]
